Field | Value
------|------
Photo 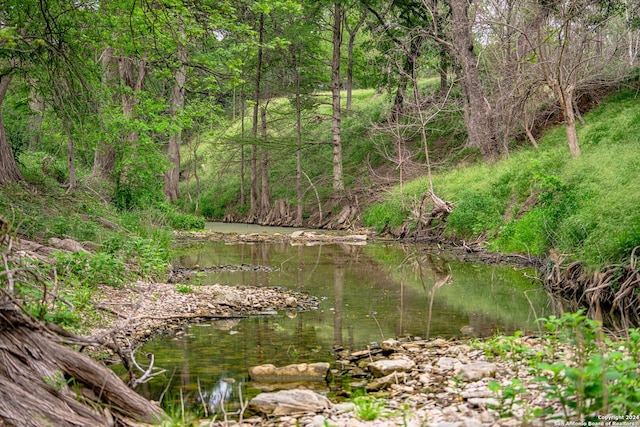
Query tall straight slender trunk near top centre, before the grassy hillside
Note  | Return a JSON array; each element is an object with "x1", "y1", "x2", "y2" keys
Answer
[{"x1": 331, "y1": 3, "x2": 344, "y2": 191}]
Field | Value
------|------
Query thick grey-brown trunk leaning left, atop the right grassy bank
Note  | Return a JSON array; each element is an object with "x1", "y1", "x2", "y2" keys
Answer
[{"x1": 449, "y1": 0, "x2": 502, "y2": 161}]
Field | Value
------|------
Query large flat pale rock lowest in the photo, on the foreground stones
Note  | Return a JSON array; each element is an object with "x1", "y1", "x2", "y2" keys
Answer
[{"x1": 249, "y1": 390, "x2": 333, "y2": 415}]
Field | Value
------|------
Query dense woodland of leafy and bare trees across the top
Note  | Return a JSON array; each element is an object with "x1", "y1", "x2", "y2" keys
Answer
[{"x1": 0, "y1": 0, "x2": 640, "y2": 217}]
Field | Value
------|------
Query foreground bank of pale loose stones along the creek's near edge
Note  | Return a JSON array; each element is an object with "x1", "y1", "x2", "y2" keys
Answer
[{"x1": 238, "y1": 337, "x2": 568, "y2": 427}]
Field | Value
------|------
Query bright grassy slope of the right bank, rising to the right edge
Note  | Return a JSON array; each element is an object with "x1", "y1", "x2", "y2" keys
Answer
[{"x1": 364, "y1": 90, "x2": 640, "y2": 268}]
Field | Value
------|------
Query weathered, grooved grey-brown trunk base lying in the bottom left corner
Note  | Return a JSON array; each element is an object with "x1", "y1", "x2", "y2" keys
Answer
[{"x1": 0, "y1": 310, "x2": 166, "y2": 427}]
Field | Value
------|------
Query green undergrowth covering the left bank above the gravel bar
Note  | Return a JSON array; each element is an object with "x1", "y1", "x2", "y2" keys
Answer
[{"x1": 0, "y1": 176, "x2": 204, "y2": 330}]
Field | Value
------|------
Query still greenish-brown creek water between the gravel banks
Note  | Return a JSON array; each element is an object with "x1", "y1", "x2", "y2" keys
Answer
[{"x1": 134, "y1": 229, "x2": 551, "y2": 409}]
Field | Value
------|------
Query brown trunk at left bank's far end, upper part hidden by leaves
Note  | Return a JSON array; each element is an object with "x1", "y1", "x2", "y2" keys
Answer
[{"x1": 164, "y1": 36, "x2": 187, "y2": 202}]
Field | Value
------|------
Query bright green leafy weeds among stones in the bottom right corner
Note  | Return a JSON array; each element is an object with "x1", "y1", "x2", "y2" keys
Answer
[{"x1": 479, "y1": 311, "x2": 640, "y2": 422}]
